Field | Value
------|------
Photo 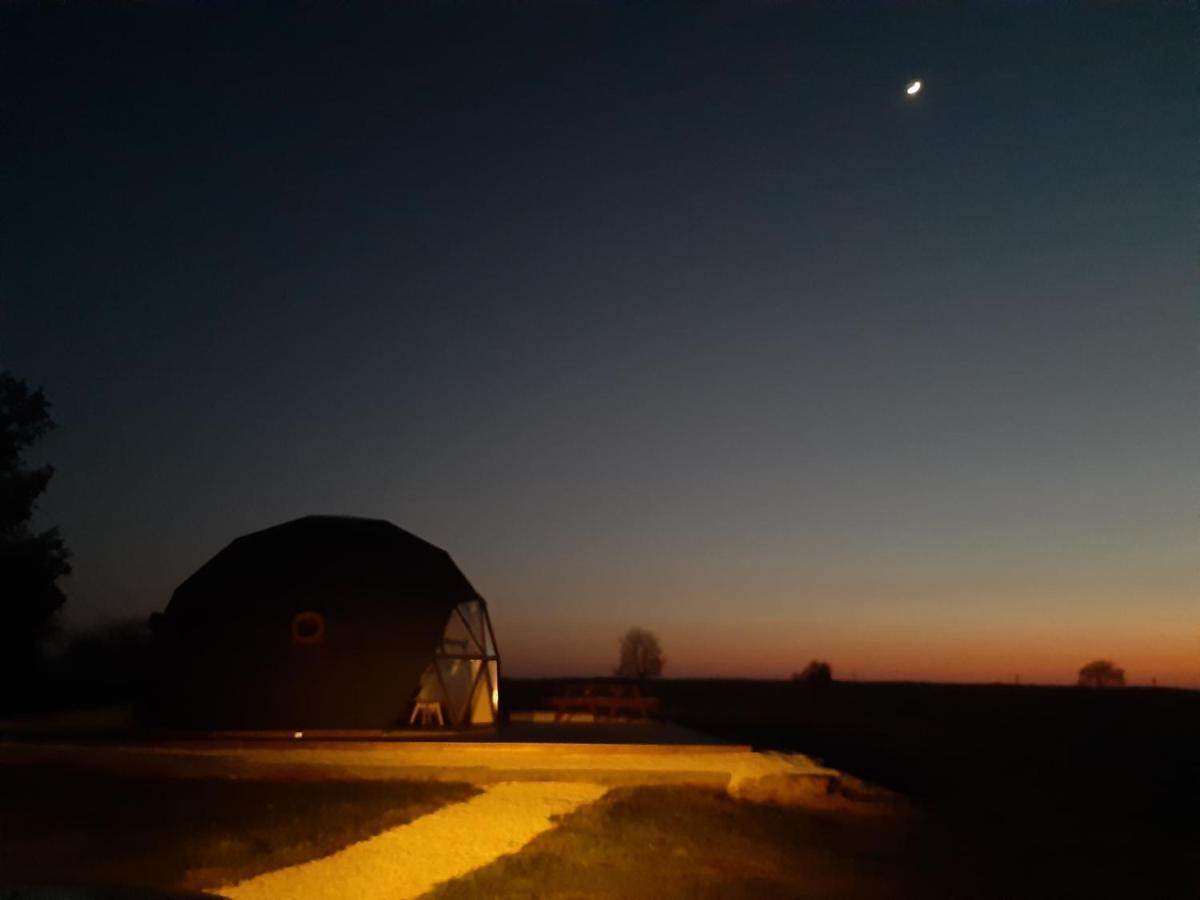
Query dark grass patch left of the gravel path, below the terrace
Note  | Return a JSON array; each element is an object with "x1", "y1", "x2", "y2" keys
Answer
[{"x1": 0, "y1": 767, "x2": 476, "y2": 889}]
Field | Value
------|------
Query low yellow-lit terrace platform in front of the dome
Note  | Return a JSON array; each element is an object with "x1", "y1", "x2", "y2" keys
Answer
[{"x1": 0, "y1": 708, "x2": 846, "y2": 796}]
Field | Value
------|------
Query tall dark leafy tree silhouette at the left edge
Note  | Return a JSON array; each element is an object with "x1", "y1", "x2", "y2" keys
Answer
[{"x1": 0, "y1": 372, "x2": 71, "y2": 684}]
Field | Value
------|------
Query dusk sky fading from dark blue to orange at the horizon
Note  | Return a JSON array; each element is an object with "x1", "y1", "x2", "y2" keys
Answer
[{"x1": 0, "y1": 2, "x2": 1200, "y2": 686}]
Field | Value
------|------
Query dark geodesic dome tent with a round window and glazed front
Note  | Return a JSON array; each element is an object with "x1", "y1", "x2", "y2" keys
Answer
[{"x1": 148, "y1": 516, "x2": 499, "y2": 731}]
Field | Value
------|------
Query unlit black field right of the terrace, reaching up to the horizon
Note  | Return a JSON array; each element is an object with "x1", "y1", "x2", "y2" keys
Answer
[{"x1": 505, "y1": 680, "x2": 1200, "y2": 898}]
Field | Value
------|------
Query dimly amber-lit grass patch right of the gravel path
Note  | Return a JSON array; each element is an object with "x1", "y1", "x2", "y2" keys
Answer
[{"x1": 432, "y1": 787, "x2": 966, "y2": 900}]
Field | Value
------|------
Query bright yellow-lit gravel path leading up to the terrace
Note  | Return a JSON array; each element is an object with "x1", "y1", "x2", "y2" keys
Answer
[{"x1": 216, "y1": 781, "x2": 607, "y2": 900}]
